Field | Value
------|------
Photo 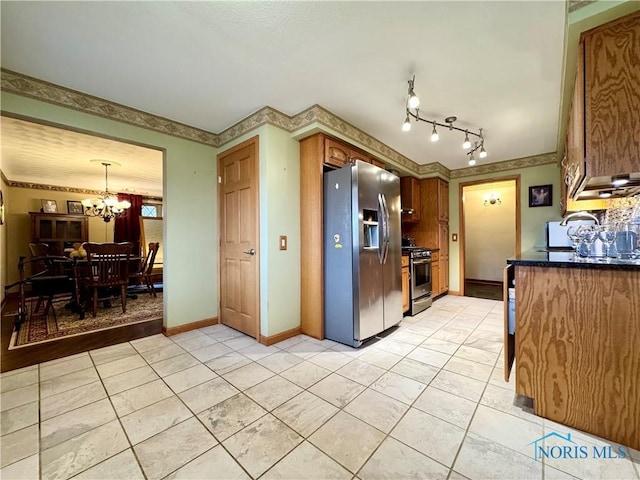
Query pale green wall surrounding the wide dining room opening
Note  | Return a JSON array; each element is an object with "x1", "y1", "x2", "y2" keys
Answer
[{"x1": 0, "y1": 91, "x2": 219, "y2": 327}]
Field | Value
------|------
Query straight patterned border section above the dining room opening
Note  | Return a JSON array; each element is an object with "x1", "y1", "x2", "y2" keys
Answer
[{"x1": 0, "y1": 68, "x2": 217, "y2": 147}]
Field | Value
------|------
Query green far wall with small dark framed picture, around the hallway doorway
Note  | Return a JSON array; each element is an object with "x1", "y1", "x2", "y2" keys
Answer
[{"x1": 449, "y1": 164, "x2": 562, "y2": 292}]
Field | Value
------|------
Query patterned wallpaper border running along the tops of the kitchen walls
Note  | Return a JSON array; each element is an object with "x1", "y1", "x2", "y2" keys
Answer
[{"x1": 0, "y1": 68, "x2": 556, "y2": 179}]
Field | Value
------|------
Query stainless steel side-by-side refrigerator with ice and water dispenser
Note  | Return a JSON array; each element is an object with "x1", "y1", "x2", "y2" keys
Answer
[{"x1": 324, "y1": 160, "x2": 402, "y2": 347}]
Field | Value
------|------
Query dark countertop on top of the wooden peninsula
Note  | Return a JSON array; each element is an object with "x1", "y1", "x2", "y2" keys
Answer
[{"x1": 507, "y1": 247, "x2": 640, "y2": 272}]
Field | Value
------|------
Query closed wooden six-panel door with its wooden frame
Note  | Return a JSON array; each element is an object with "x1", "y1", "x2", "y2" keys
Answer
[{"x1": 218, "y1": 137, "x2": 260, "y2": 340}]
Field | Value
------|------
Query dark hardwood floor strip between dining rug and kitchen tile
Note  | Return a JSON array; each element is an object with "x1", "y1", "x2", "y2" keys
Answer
[{"x1": 0, "y1": 300, "x2": 162, "y2": 372}]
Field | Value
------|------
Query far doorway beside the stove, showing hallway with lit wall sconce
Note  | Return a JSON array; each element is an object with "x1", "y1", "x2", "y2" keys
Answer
[{"x1": 460, "y1": 175, "x2": 520, "y2": 300}]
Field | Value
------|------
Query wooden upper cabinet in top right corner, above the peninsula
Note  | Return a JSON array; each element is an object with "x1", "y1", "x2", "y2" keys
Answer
[{"x1": 562, "y1": 12, "x2": 640, "y2": 199}]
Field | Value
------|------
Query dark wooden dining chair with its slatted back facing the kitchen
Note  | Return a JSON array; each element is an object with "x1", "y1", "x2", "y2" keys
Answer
[{"x1": 81, "y1": 242, "x2": 133, "y2": 317}]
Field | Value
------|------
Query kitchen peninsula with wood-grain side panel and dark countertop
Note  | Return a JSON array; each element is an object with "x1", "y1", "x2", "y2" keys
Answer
[{"x1": 505, "y1": 249, "x2": 640, "y2": 449}]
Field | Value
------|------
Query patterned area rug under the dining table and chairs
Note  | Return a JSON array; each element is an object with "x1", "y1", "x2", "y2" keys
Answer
[{"x1": 9, "y1": 293, "x2": 162, "y2": 350}]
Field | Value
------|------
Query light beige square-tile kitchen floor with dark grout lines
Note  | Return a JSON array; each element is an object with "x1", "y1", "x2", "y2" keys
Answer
[{"x1": 0, "y1": 297, "x2": 640, "y2": 480}]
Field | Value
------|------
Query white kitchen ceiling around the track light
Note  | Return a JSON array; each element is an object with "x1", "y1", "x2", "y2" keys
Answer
[{"x1": 1, "y1": 1, "x2": 567, "y2": 184}]
